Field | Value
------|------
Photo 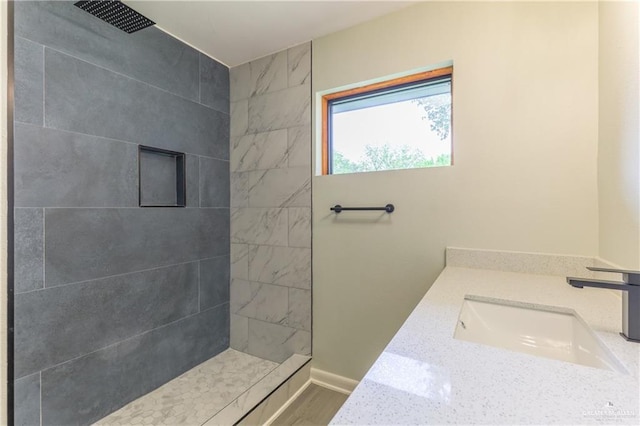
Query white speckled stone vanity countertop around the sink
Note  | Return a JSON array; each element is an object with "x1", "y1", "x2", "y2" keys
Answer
[{"x1": 331, "y1": 254, "x2": 640, "y2": 425}]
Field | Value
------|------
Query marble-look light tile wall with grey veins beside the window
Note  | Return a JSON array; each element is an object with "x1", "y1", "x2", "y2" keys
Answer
[{"x1": 229, "y1": 43, "x2": 311, "y2": 362}]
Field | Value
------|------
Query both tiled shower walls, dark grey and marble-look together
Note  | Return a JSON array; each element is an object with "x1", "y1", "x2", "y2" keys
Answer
[{"x1": 13, "y1": 1, "x2": 311, "y2": 425}]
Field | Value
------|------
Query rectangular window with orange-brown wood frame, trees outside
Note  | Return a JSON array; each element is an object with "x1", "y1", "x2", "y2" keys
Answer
[{"x1": 322, "y1": 67, "x2": 453, "y2": 175}]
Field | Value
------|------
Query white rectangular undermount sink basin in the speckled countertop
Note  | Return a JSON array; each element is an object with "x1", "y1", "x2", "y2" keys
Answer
[{"x1": 453, "y1": 295, "x2": 627, "y2": 374}]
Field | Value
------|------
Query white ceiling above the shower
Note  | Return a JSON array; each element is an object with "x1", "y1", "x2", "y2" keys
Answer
[{"x1": 124, "y1": 0, "x2": 416, "y2": 67}]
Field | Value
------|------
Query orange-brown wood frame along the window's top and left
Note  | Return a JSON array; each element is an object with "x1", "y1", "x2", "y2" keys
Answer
[{"x1": 322, "y1": 66, "x2": 453, "y2": 175}]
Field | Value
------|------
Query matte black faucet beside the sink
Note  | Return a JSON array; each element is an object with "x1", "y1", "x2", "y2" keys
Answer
[{"x1": 567, "y1": 266, "x2": 640, "y2": 343}]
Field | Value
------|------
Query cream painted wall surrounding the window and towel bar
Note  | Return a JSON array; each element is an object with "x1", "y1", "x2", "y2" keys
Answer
[{"x1": 312, "y1": 2, "x2": 598, "y2": 379}]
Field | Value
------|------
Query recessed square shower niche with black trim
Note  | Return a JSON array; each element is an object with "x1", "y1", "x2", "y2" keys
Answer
[{"x1": 138, "y1": 145, "x2": 186, "y2": 207}]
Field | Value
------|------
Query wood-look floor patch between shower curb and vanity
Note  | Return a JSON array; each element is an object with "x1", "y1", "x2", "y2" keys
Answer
[{"x1": 272, "y1": 383, "x2": 347, "y2": 426}]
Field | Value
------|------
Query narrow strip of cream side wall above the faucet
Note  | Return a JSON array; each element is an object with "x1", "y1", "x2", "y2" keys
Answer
[{"x1": 598, "y1": 2, "x2": 640, "y2": 269}]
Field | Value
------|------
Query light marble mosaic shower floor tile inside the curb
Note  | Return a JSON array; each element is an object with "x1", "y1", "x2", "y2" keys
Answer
[{"x1": 95, "y1": 349, "x2": 280, "y2": 425}]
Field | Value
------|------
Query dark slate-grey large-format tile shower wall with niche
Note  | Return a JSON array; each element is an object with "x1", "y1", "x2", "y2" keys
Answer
[{"x1": 14, "y1": 1, "x2": 230, "y2": 425}]
